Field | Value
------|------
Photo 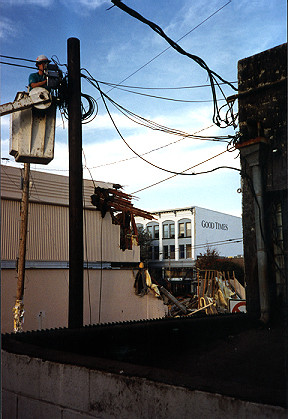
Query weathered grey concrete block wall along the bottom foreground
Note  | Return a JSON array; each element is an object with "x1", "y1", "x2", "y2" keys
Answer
[{"x1": 2, "y1": 351, "x2": 288, "y2": 419}]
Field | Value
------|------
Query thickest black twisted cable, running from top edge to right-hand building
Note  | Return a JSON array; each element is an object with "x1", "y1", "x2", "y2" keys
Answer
[{"x1": 111, "y1": 0, "x2": 237, "y2": 128}]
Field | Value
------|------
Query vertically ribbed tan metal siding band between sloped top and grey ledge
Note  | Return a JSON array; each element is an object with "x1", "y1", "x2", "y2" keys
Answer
[{"x1": 1, "y1": 199, "x2": 139, "y2": 262}]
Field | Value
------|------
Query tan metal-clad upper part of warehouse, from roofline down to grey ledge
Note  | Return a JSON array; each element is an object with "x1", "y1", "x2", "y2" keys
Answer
[{"x1": 1, "y1": 167, "x2": 140, "y2": 262}]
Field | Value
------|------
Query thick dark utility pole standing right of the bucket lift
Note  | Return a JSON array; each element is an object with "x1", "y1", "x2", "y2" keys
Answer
[{"x1": 67, "y1": 38, "x2": 83, "y2": 328}]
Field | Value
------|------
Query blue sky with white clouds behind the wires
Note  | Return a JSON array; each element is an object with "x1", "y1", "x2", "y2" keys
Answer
[{"x1": 0, "y1": 0, "x2": 286, "y2": 215}]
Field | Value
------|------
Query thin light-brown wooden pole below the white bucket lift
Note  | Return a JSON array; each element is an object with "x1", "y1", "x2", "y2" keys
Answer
[{"x1": 13, "y1": 163, "x2": 30, "y2": 332}]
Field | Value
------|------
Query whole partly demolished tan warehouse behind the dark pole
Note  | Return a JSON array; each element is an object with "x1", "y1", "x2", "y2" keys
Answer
[{"x1": 1, "y1": 166, "x2": 166, "y2": 333}]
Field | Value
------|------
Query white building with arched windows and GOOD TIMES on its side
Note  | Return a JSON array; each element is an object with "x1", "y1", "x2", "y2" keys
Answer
[{"x1": 135, "y1": 206, "x2": 243, "y2": 269}]
